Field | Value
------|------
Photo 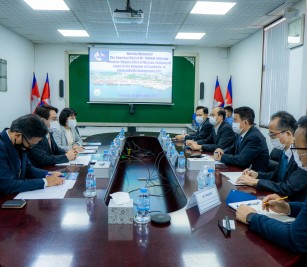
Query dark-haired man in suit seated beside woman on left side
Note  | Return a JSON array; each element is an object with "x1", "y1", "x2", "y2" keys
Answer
[{"x1": 27, "y1": 105, "x2": 78, "y2": 167}]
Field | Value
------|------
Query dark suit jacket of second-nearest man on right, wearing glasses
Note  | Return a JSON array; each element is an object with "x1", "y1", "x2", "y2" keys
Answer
[{"x1": 256, "y1": 154, "x2": 307, "y2": 201}]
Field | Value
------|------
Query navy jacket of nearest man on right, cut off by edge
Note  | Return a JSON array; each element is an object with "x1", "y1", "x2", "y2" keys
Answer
[{"x1": 249, "y1": 201, "x2": 307, "y2": 253}]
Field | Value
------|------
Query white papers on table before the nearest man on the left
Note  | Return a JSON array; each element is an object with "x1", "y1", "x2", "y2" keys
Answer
[{"x1": 15, "y1": 180, "x2": 76, "y2": 199}]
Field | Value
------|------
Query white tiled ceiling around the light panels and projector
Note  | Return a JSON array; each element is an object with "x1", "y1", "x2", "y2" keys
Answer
[{"x1": 0, "y1": 0, "x2": 299, "y2": 47}]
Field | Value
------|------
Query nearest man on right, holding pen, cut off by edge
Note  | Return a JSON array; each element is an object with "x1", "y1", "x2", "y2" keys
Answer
[{"x1": 236, "y1": 116, "x2": 307, "y2": 253}]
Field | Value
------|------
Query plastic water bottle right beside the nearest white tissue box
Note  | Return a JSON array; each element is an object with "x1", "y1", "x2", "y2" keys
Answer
[{"x1": 134, "y1": 188, "x2": 150, "y2": 223}]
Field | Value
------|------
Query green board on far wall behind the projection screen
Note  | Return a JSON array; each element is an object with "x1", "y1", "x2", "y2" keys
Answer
[{"x1": 68, "y1": 54, "x2": 195, "y2": 124}]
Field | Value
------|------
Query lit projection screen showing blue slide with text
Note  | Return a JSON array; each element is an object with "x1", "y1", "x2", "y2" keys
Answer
[{"x1": 89, "y1": 47, "x2": 173, "y2": 104}]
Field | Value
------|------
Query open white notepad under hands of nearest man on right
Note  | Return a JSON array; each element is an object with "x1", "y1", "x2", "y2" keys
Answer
[{"x1": 228, "y1": 199, "x2": 295, "y2": 223}]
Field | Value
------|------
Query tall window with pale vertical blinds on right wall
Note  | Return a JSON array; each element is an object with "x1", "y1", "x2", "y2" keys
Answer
[{"x1": 260, "y1": 19, "x2": 289, "y2": 127}]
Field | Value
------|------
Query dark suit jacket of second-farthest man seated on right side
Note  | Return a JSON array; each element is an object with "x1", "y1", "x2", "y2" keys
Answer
[{"x1": 197, "y1": 121, "x2": 236, "y2": 151}]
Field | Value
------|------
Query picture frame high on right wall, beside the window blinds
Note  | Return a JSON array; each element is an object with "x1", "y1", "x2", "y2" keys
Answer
[{"x1": 287, "y1": 15, "x2": 305, "y2": 48}]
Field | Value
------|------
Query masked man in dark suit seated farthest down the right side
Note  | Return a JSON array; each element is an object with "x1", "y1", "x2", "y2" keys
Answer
[{"x1": 175, "y1": 106, "x2": 212, "y2": 141}]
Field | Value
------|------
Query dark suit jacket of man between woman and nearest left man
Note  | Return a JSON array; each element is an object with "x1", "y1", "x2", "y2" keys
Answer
[{"x1": 27, "y1": 134, "x2": 68, "y2": 167}]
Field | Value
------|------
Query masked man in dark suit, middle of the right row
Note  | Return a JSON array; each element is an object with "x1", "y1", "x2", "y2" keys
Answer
[{"x1": 214, "y1": 107, "x2": 269, "y2": 171}]
